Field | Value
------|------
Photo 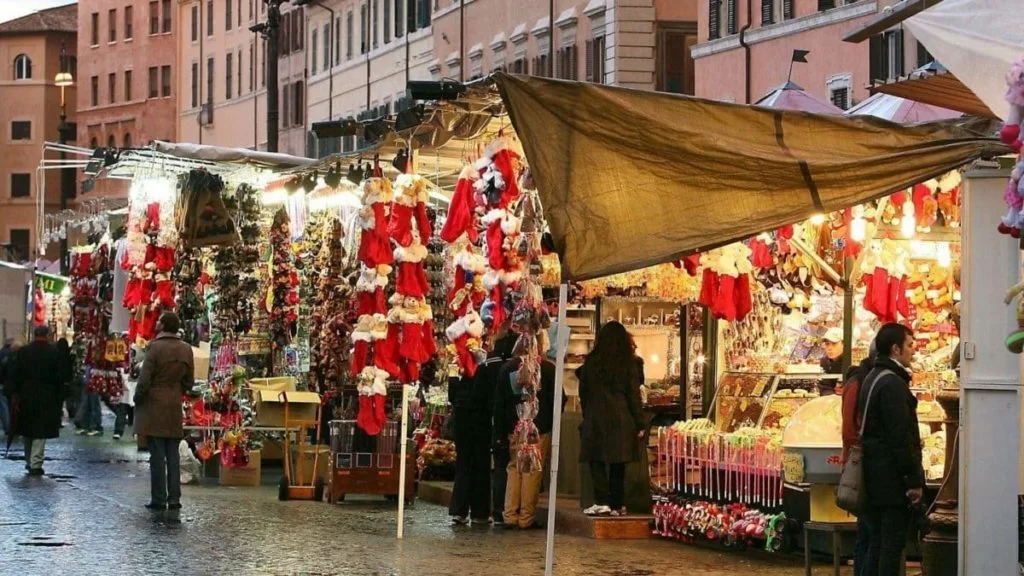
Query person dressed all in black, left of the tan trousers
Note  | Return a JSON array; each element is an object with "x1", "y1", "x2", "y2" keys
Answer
[{"x1": 449, "y1": 333, "x2": 515, "y2": 525}]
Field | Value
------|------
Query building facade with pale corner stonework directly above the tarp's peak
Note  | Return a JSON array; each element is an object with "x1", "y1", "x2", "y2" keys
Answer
[{"x1": 431, "y1": 0, "x2": 697, "y2": 94}]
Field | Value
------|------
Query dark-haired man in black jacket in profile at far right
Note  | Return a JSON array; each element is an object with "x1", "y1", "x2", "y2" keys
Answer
[{"x1": 857, "y1": 324, "x2": 925, "y2": 576}]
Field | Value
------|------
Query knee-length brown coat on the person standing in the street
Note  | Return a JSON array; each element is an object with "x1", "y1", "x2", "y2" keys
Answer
[{"x1": 135, "y1": 332, "x2": 195, "y2": 438}]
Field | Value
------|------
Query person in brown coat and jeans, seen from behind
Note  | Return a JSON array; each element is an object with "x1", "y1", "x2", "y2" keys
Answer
[{"x1": 134, "y1": 312, "x2": 196, "y2": 510}]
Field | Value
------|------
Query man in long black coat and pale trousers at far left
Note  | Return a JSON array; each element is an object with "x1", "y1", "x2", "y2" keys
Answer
[{"x1": 12, "y1": 326, "x2": 63, "y2": 476}]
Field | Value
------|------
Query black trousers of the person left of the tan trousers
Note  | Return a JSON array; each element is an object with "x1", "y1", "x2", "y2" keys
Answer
[{"x1": 449, "y1": 408, "x2": 490, "y2": 521}]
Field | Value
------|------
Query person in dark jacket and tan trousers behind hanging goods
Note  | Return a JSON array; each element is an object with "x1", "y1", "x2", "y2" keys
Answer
[{"x1": 494, "y1": 338, "x2": 567, "y2": 530}]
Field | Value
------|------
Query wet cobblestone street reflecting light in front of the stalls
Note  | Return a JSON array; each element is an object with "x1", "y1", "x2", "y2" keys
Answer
[{"x1": 0, "y1": 422, "x2": 847, "y2": 576}]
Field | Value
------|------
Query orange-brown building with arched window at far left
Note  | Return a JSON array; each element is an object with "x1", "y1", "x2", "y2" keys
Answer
[{"x1": 0, "y1": 4, "x2": 78, "y2": 261}]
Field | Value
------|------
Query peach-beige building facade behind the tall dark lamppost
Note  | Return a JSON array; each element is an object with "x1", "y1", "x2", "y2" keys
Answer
[{"x1": 177, "y1": 0, "x2": 307, "y2": 156}]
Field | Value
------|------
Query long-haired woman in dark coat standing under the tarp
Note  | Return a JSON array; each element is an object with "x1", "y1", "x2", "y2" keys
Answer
[{"x1": 577, "y1": 322, "x2": 646, "y2": 516}]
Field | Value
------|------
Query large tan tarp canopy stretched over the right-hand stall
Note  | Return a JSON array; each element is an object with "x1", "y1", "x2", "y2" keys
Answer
[{"x1": 496, "y1": 74, "x2": 1008, "y2": 280}]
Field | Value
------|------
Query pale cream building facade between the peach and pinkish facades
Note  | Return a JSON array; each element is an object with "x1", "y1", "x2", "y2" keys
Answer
[{"x1": 306, "y1": 0, "x2": 435, "y2": 156}]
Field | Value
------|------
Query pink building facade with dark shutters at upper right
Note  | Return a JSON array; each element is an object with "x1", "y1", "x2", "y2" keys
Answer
[{"x1": 692, "y1": 0, "x2": 932, "y2": 110}]
